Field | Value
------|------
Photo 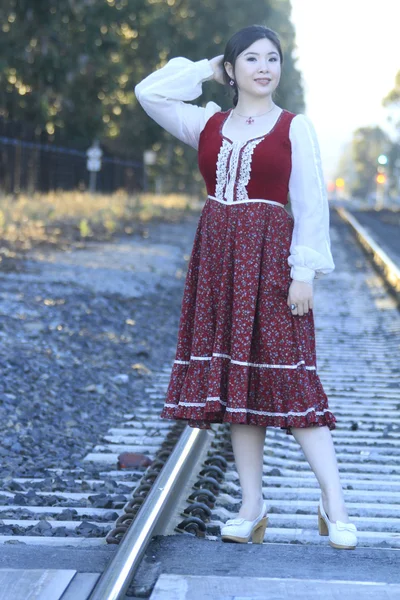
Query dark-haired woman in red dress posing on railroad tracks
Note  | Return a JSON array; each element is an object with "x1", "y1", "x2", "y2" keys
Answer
[{"x1": 135, "y1": 25, "x2": 357, "y2": 548}]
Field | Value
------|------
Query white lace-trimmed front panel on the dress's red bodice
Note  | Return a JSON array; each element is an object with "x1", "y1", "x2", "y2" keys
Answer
[{"x1": 215, "y1": 137, "x2": 264, "y2": 204}]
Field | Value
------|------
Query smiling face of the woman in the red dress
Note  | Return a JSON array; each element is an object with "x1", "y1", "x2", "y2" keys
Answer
[{"x1": 225, "y1": 38, "x2": 281, "y2": 97}]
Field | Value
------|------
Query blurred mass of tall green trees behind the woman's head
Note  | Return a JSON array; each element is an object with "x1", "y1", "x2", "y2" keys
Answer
[{"x1": 0, "y1": 0, "x2": 304, "y2": 192}]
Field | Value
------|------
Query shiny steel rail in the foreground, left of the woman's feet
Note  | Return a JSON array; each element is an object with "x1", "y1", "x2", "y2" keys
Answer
[{"x1": 88, "y1": 426, "x2": 213, "y2": 600}]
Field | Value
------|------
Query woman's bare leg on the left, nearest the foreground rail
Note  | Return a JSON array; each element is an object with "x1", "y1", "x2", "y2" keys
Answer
[{"x1": 231, "y1": 423, "x2": 266, "y2": 521}]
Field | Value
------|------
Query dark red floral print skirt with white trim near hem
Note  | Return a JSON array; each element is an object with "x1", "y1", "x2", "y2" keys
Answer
[{"x1": 160, "y1": 198, "x2": 336, "y2": 434}]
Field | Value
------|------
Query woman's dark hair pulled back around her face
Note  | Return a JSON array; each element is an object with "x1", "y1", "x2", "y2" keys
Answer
[{"x1": 222, "y1": 25, "x2": 283, "y2": 106}]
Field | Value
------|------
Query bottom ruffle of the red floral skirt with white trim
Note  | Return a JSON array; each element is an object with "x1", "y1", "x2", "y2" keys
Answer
[{"x1": 161, "y1": 357, "x2": 336, "y2": 434}]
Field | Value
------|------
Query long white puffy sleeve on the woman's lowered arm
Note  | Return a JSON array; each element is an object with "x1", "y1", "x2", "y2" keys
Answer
[{"x1": 288, "y1": 114, "x2": 335, "y2": 283}]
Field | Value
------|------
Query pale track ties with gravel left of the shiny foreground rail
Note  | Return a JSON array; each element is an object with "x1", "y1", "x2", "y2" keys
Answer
[{"x1": 0, "y1": 371, "x2": 182, "y2": 547}]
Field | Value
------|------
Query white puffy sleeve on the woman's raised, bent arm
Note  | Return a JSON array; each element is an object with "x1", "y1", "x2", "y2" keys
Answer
[{"x1": 135, "y1": 56, "x2": 221, "y2": 150}]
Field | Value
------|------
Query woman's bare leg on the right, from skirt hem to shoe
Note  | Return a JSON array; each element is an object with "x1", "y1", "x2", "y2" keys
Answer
[{"x1": 292, "y1": 425, "x2": 349, "y2": 523}]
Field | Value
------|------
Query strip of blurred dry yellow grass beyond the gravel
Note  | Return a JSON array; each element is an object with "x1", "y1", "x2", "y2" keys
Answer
[{"x1": 0, "y1": 191, "x2": 199, "y2": 256}]
